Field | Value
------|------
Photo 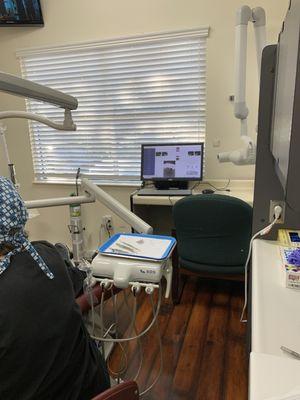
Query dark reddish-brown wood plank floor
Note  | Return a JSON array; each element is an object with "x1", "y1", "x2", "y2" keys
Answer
[{"x1": 107, "y1": 277, "x2": 248, "y2": 400}]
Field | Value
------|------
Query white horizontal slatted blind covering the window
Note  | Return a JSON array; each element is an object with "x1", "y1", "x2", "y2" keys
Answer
[{"x1": 17, "y1": 28, "x2": 208, "y2": 182}]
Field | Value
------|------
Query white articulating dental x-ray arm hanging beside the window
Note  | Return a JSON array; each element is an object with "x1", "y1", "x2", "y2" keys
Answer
[{"x1": 218, "y1": 6, "x2": 266, "y2": 165}]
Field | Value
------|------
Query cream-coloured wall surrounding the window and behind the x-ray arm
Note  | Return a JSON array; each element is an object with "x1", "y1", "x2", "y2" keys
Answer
[{"x1": 0, "y1": 0, "x2": 289, "y2": 247}]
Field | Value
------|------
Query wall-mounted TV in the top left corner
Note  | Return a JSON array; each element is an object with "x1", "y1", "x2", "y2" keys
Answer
[{"x1": 0, "y1": 0, "x2": 44, "y2": 26}]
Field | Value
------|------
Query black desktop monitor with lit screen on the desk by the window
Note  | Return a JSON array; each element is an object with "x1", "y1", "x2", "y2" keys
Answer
[{"x1": 141, "y1": 143, "x2": 203, "y2": 181}]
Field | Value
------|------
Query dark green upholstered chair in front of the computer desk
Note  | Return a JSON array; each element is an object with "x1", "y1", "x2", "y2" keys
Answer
[{"x1": 172, "y1": 194, "x2": 252, "y2": 304}]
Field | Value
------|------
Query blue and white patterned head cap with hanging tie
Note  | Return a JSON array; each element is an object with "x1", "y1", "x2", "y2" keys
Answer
[{"x1": 0, "y1": 176, "x2": 54, "y2": 279}]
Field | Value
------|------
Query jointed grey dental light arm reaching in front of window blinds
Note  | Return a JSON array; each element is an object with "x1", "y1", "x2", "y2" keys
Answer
[{"x1": 0, "y1": 72, "x2": 78, "y2": 131}]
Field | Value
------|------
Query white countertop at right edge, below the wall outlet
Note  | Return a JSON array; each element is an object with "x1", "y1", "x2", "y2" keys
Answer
[{"x1": 249, "y1": 239, "x2": 300, "y2": 400}]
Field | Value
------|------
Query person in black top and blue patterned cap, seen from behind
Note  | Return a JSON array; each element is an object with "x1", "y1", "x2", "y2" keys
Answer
[{"x1": 0, "y1": 177, "x2": 109, "y2": 400}]
